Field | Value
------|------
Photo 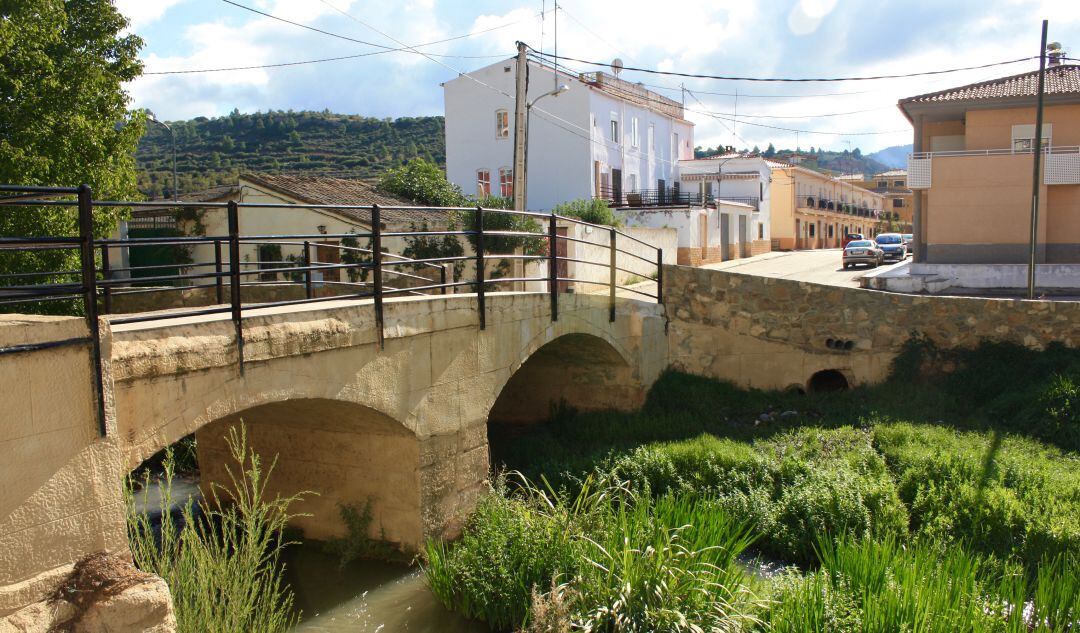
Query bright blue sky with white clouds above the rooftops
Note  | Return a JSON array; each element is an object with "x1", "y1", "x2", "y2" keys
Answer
[{"x1": 116, "y1": 0, "x2": 1080, "y2": 152}]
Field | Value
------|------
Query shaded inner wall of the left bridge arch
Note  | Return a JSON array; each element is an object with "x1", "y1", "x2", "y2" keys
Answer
[{"x1": 195, "y1": 398, "x2": 423, "y2": 549}]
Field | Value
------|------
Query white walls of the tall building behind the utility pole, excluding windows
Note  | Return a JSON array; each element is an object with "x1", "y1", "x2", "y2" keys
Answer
[{"x1": 443, "y1": 58, "x2": 693, "y2": 211}]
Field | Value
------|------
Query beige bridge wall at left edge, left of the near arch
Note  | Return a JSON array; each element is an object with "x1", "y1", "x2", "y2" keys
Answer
[{"x1": 0, "y1": 314, "x2": 127, "y2": 617}]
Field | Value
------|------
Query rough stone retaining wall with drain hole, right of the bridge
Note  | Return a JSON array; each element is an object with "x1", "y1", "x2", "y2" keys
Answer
[{"x1": 664, "y1": 266, "x2": 1080, "y2": 389}]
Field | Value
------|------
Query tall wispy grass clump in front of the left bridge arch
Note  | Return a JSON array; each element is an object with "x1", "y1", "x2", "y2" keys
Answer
[{"x1": 126, "y1": 427, "x2": 299, "y2": 633}]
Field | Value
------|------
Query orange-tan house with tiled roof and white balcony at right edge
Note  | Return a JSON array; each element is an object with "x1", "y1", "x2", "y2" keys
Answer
[{"x1": 899, "y1": 59, "x2": 1080, "y2": 265}]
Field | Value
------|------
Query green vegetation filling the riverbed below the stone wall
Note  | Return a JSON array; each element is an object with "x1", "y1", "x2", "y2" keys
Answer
[{"x1": 427, "y1": 340, "x2": 1080, "y2": 632}]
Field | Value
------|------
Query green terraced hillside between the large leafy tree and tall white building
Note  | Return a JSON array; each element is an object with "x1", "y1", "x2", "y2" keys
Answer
[{"x1": 135, "y1": 110, "x2": 446, "y2": 198}]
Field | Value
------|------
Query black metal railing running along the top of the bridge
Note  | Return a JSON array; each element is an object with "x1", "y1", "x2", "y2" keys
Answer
[{"x1": 0, "y1": 185, "x2": 663, "y2": 435}]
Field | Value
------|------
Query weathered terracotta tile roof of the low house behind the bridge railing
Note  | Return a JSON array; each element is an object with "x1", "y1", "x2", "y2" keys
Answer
[{"x1": 240, "y1": 174, "x2": 447, "y2": 225}]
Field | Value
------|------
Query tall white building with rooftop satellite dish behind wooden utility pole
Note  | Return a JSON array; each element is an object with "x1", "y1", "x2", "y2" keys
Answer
[{"x1": 443, "y1": 58, "x2": 693, "y2": 211}]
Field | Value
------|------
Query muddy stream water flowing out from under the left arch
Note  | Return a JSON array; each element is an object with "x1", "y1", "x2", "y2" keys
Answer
[{"x1": 285, "y1": 543, "x2": 487, "y2": 633}]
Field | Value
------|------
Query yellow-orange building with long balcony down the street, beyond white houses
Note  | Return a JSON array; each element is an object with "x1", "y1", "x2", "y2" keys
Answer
[{"x1": 770, "y1": 161, "x2": 885, "y2": 251}]
